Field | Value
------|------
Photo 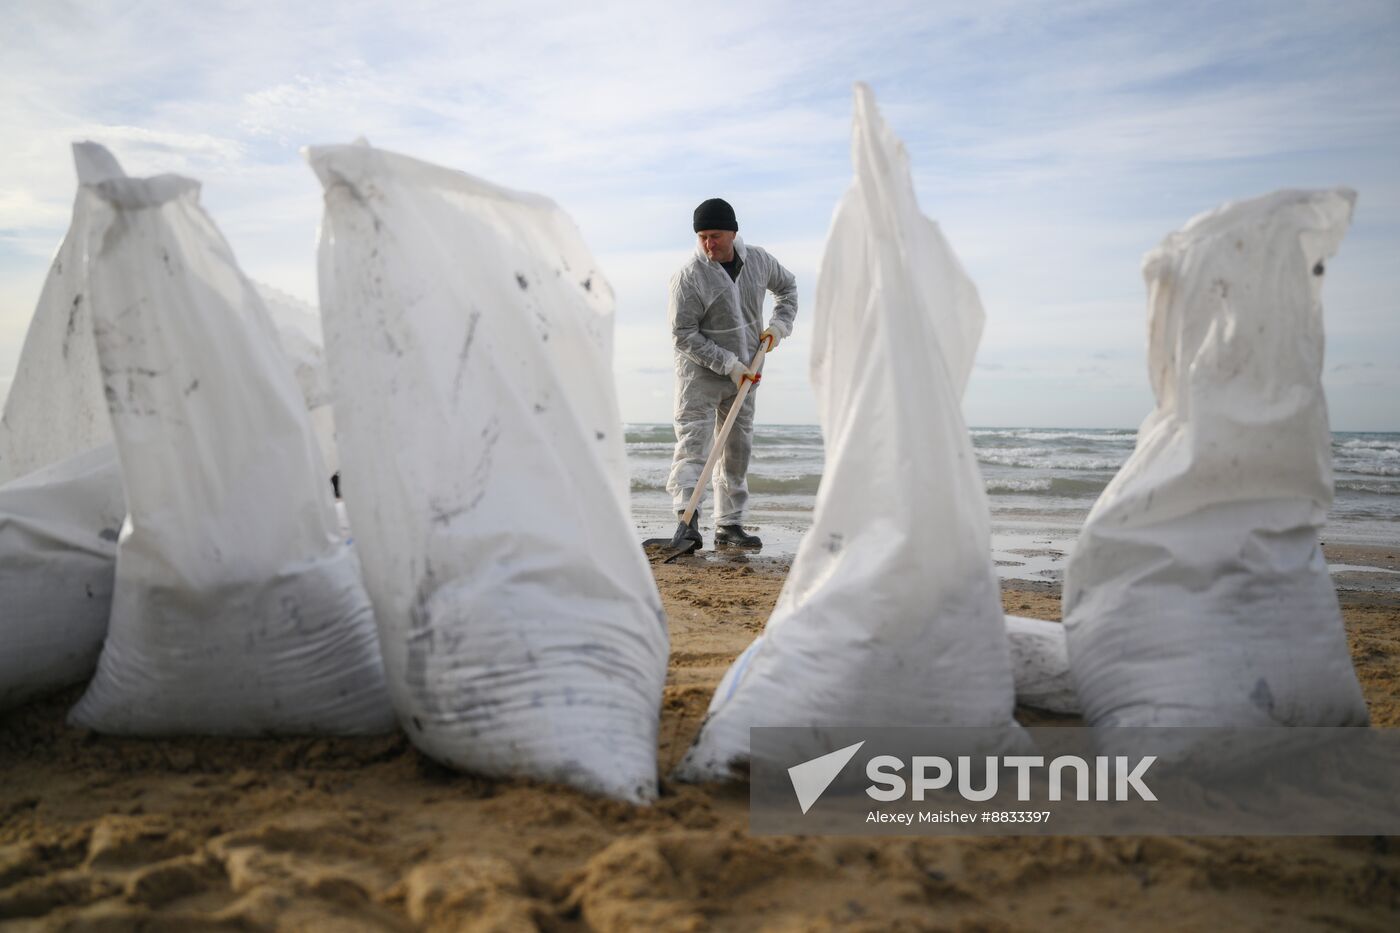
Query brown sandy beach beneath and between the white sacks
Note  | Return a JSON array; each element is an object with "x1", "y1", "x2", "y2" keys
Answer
[{"x1": 0, "y1": 545, "x2": 1400, "y2": 932}]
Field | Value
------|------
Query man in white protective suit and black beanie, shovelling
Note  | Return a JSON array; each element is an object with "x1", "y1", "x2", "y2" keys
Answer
[{"x1": 666, "y1": 198, "x2": 797, "y2": 549}]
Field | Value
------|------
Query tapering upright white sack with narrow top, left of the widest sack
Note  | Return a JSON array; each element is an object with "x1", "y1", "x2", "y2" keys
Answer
[{"x1": 70, "y1": 167, "x2": 393, "y2": 734}]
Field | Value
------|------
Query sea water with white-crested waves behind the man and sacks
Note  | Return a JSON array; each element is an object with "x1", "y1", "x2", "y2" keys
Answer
[{"x1": 627, "y1": 424, "x2": 1400, "y2": 581}]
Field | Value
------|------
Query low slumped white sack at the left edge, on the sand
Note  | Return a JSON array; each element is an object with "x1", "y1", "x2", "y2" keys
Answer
[{"x1": 0, "y1": 444, "x2": 126, "y2": 709}]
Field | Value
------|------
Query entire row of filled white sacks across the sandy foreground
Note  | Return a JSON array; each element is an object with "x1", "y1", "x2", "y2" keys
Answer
[{"x1": 0, "y1": 85, "x2": 1366, "y2": 801}]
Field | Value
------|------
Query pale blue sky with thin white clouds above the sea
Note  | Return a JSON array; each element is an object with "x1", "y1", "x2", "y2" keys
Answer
[{"x1": 0, "y1": 0, "x2": 1400, "y2": 430}]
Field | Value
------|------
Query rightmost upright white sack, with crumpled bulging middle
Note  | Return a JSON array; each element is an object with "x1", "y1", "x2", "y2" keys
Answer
[{"x1": 1064, "y1": 189, "x2": 1366, "y2": 726}]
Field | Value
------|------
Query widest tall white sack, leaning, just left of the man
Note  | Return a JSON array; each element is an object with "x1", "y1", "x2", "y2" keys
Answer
[{"x1": 308, "y1": 144, "x2": 668, "y2": 801}]
